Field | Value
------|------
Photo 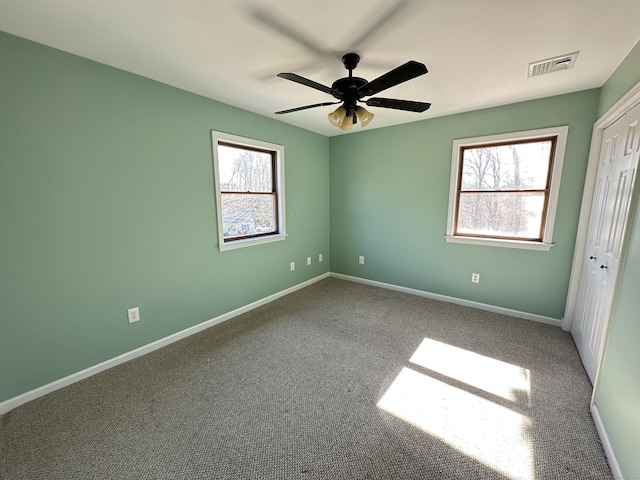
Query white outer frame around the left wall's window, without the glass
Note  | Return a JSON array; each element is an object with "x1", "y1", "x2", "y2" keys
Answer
[{"x1": 211, "y1": 130, "x2": 287, "y2": 252}]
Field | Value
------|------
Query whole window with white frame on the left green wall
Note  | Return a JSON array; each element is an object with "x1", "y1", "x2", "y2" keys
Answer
[{"x1": 212, "y1": 131, "x2": 286, "y2": 250}]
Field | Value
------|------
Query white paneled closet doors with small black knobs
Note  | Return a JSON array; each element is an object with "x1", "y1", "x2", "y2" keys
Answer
[{"x1": 571, "y1": 106, "x2": 640, "y2": 382}]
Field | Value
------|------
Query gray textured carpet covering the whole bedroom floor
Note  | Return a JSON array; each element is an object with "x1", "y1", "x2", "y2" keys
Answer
[{"x1": 0, "y1": 278, "x2": 612, "y2": 480}]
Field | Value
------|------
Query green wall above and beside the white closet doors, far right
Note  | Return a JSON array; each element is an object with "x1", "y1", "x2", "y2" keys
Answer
[{"x1": 595, "y1": 42, "x2": 640, "y2": 479}]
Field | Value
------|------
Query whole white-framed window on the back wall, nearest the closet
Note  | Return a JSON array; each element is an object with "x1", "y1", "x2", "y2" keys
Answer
[{"x1": 446, "y1": 127, "x2": 568, "y2": 250}]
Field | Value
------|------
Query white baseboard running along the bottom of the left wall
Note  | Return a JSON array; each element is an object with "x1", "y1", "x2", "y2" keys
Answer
[{"x1": 0, "y1": 273, "x2": 329, "y2": 415}]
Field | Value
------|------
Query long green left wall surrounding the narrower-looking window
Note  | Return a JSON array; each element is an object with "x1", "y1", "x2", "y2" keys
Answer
[{"x1": 0, "y1": 33, "x2": 330, "y2": 401}]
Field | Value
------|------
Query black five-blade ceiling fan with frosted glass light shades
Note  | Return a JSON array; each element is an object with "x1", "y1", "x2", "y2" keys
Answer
[{"x1": 275, "y1": 53, "x2": 431, "y2": 130}]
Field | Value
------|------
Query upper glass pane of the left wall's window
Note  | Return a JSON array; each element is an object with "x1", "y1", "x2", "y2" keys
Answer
[{"x1": 218, "y1": 145, "x2": 273, "y2": 192}]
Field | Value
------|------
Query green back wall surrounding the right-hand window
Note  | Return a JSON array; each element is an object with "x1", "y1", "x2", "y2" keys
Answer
[{"x1": 331, "y1": 90, "x2": 599, "y2": 319}]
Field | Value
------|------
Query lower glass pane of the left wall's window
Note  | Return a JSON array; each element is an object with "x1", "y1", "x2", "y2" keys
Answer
[{"x1": 222, "y1": 193, "x2": 277, "y2": 238}]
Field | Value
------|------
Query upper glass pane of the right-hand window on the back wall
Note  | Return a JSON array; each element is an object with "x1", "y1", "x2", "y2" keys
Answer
[{"x1": 461, "y1": 140, "x2": 552, "y2": 191}]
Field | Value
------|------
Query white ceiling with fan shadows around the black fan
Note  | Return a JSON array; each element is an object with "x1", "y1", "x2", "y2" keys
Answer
[{"x1": 0, "y1": 0, "x2": 640, "y2": 136}]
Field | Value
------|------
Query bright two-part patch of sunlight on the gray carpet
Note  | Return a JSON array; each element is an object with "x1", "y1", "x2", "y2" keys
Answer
[{"x1": 377, "y1": 339, "x2": 534, "y2": 480}]
